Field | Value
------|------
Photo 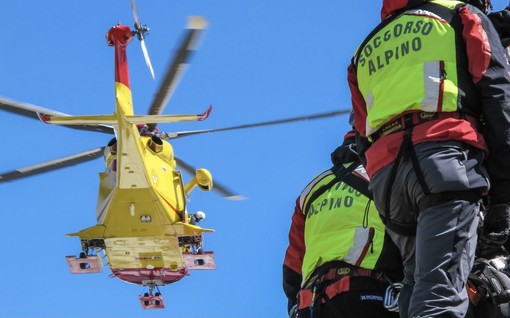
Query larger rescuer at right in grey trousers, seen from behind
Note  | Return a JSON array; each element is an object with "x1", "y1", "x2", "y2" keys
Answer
[{"x1": 348, "y1": 0, "x2": 510, "y2": 318}]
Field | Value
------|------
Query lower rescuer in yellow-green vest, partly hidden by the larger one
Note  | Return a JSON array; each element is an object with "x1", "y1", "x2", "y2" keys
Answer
[{"x1": 283, "y1": 131, "x2": 403, "y2": 318}]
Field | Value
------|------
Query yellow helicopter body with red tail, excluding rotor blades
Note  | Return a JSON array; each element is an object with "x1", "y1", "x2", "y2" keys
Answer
[{"x1": 48, "y1": 25, "x2": 215, "y2": 286}]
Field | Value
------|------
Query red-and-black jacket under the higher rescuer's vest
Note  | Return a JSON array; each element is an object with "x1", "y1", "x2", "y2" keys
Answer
[{"x1": 348, "y1": 0, "x2": 510, "y2": 202}]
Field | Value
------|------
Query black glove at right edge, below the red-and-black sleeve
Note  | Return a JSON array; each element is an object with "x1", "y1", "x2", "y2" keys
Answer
[{"x1": 476, "y1": 204, "x2": 510, "y2": 258}]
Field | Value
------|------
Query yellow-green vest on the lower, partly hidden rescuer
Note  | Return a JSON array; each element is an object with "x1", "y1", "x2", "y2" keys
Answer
[{"x1": 299, "y1": 166, "x2": 384, "y2": 281}]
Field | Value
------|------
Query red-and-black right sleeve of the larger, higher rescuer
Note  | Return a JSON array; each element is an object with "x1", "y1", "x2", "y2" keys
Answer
[{"x1": 460, "y1": 6, "x2": 510, "y2": 204}]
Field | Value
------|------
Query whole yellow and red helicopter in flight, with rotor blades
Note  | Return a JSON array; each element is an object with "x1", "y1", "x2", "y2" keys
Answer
[{"x1": 0, "y1": 0, "x2": 350, "y2": 309}]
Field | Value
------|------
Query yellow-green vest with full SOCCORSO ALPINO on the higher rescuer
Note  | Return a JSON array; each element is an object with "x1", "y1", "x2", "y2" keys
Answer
[{"x1": 355, "y1": 0, "x2": 461, "y2": 136}]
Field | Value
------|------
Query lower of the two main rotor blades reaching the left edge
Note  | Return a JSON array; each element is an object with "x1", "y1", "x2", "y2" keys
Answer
[{"x1": 0, "y1": 147, "x2": 105, "y2": 182}]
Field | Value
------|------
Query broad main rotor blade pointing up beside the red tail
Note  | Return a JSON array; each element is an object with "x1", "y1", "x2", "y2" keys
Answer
[{"x1": 149, "y1": 17, "x2": 207, "y2": 131}]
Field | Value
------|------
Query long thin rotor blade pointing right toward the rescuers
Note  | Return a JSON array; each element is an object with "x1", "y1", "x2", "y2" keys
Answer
[{"x1": 159, "y1": 109, "x2": 351, "y2": 139}]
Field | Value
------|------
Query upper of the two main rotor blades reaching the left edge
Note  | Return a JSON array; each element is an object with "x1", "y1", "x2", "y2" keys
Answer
[{"x1": 0, "y1": 97, "x2": 114, "y2": 134}]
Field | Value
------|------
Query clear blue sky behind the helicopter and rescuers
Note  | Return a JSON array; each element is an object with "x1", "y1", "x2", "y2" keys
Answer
[{"x1": 0, "y1": 0, "x2": 506, "y2": 318}]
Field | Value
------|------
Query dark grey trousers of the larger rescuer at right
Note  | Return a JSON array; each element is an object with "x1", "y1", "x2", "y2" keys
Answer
[{"x1": 371, "y1": 141, "x2": 488, "y2": 318}]
